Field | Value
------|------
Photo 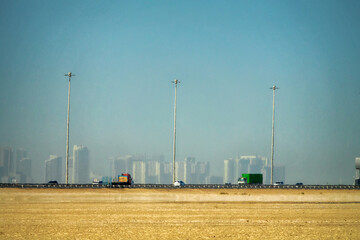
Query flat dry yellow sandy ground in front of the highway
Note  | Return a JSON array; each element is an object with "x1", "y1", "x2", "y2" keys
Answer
[{"x1": 0, "y1": 188, "x2": 360, "y2": 239}]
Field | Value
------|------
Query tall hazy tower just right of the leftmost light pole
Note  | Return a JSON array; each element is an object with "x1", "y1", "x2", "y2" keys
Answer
[{"x1": 72, "y1": 145, "x2": 91, "y2": 183}]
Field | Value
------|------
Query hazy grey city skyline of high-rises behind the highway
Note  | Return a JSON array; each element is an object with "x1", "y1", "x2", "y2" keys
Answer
[{"x1": 4, "y1": 145, "x2": 360, "y2": 185}]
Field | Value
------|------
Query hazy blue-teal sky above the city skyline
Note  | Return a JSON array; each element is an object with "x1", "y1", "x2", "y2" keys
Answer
[{"x1": 0, "y1": 0, "x2": 360, "y2": 184}]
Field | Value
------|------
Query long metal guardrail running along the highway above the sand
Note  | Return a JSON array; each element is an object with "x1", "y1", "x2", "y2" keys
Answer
[{"x1": 0, "y1": 183, "x2": 360, "y2": 190}]
